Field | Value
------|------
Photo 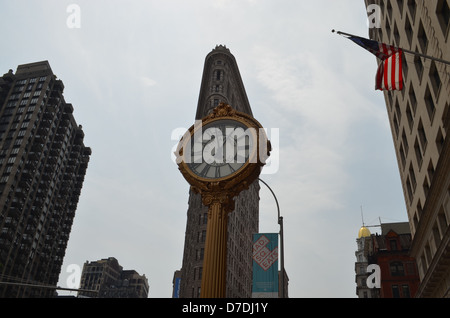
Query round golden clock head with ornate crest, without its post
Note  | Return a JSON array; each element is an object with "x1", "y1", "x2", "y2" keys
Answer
[{"x1": 175, "y1": 104, "x2": 270, "y2": 198}]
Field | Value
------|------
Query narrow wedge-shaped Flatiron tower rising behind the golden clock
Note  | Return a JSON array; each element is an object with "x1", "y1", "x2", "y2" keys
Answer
[{"x1": 179, "y1": 45, "x2": 260, "y2": 298}]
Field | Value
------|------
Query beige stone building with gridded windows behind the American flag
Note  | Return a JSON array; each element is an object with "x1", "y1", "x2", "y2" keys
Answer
[{"x1": 365, "y1": 0, "x2": 450, "y2": 297}]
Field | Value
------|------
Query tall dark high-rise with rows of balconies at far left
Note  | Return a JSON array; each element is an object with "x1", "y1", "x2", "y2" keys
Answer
[{"x1": 0, "y1": 61, "x2": 91, "y2": 297}]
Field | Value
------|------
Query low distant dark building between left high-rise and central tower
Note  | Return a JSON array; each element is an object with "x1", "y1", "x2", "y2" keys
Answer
[{"x1": 78, "y1": 257, "x2": 149, "y2": 298}]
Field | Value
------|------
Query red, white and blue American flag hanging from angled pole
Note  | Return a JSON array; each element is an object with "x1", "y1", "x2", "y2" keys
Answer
[{"x1": 348, "y1": 36, "x2": 403, "y2": 91}]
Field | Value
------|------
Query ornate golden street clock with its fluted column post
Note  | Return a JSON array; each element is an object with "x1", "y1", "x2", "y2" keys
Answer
[{"x1": 175, "y1": 103, "x2": 270, "y2": 298}]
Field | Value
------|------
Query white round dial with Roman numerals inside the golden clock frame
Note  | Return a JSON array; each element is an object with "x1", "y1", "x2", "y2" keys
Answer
[{"x1": 185, "y1": 119, "x2": 256, "y2": 179}]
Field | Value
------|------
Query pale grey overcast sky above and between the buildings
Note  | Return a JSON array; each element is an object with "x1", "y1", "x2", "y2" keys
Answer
[{"x1": 0, "y1": 0, "x2": 407, "y2": 298}]
